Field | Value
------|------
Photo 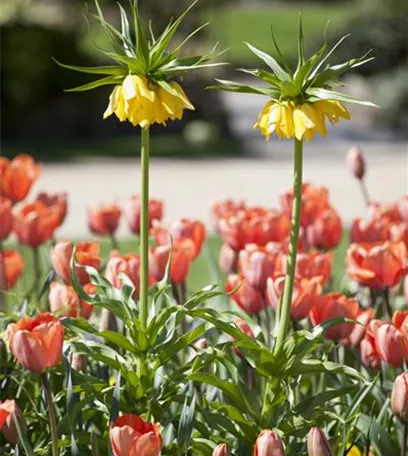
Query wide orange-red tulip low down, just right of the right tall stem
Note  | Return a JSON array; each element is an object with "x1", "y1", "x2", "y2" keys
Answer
[{"x1": 310, "y1": 293, "x2": 360, "y2": 341}]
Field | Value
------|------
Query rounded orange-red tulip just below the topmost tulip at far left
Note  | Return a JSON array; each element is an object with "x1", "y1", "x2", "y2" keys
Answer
[{"x1": 13, "y1": 201, "x2": 59, "y2": 247}]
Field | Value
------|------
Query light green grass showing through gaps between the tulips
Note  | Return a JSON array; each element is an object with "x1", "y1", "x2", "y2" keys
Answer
[{"x1": 9, "y1": 233, "x2": 348, "y2": 308}]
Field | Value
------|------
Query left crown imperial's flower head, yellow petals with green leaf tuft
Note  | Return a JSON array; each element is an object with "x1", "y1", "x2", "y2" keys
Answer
[{"x1": 55, "y1": 0, "x2": 223, "y2": 128}]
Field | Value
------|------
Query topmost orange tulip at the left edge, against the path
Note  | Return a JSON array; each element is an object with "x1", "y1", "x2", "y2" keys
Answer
[{"x1": 0, "y1": 154, "x2": 41, "y2": 202}]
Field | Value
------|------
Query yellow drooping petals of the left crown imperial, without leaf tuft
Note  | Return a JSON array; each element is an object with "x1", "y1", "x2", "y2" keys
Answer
[{"x1": 103, "y1": 75, "x2": 194, "y2": 128}]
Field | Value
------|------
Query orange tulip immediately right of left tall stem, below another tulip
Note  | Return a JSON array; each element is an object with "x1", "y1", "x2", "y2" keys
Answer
[{"x1": 150, "y1": 238, "x2": 195, "y2": 283}]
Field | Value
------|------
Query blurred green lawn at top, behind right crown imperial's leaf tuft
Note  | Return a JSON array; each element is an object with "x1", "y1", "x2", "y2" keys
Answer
[{"x1": 208, "y1": 2, "x2": 354, "y2": 65}]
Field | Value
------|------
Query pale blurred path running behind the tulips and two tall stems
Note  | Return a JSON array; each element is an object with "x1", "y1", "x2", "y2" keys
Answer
[{"x1": 32, "y1": 136, "x2": 408, "y2": 238}]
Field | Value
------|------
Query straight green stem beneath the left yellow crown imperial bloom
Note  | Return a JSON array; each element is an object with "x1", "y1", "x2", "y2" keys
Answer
[{"x1": 139, "y1": 127, "x2": 150, "y2": 328}]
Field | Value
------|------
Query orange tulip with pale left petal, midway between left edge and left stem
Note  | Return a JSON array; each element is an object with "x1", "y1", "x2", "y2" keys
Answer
[{"x1": 51, "y1": 241, "x2": 102, "y2": 285}]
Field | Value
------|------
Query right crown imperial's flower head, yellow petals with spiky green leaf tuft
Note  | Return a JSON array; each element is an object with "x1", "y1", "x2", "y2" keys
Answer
[{"x1": 212, "y1": 19, "x2": 374, "y2": 141}]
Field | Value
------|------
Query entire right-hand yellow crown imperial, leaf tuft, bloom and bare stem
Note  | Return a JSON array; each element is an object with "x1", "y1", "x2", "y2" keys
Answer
[{"x1": 213, "y1": 19, "x2": 374, "y2": 353}]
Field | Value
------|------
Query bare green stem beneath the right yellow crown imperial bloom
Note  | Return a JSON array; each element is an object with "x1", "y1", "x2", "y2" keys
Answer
[{"x1": 275, "y1": 139, "x2": 303, "y2": 353}]
